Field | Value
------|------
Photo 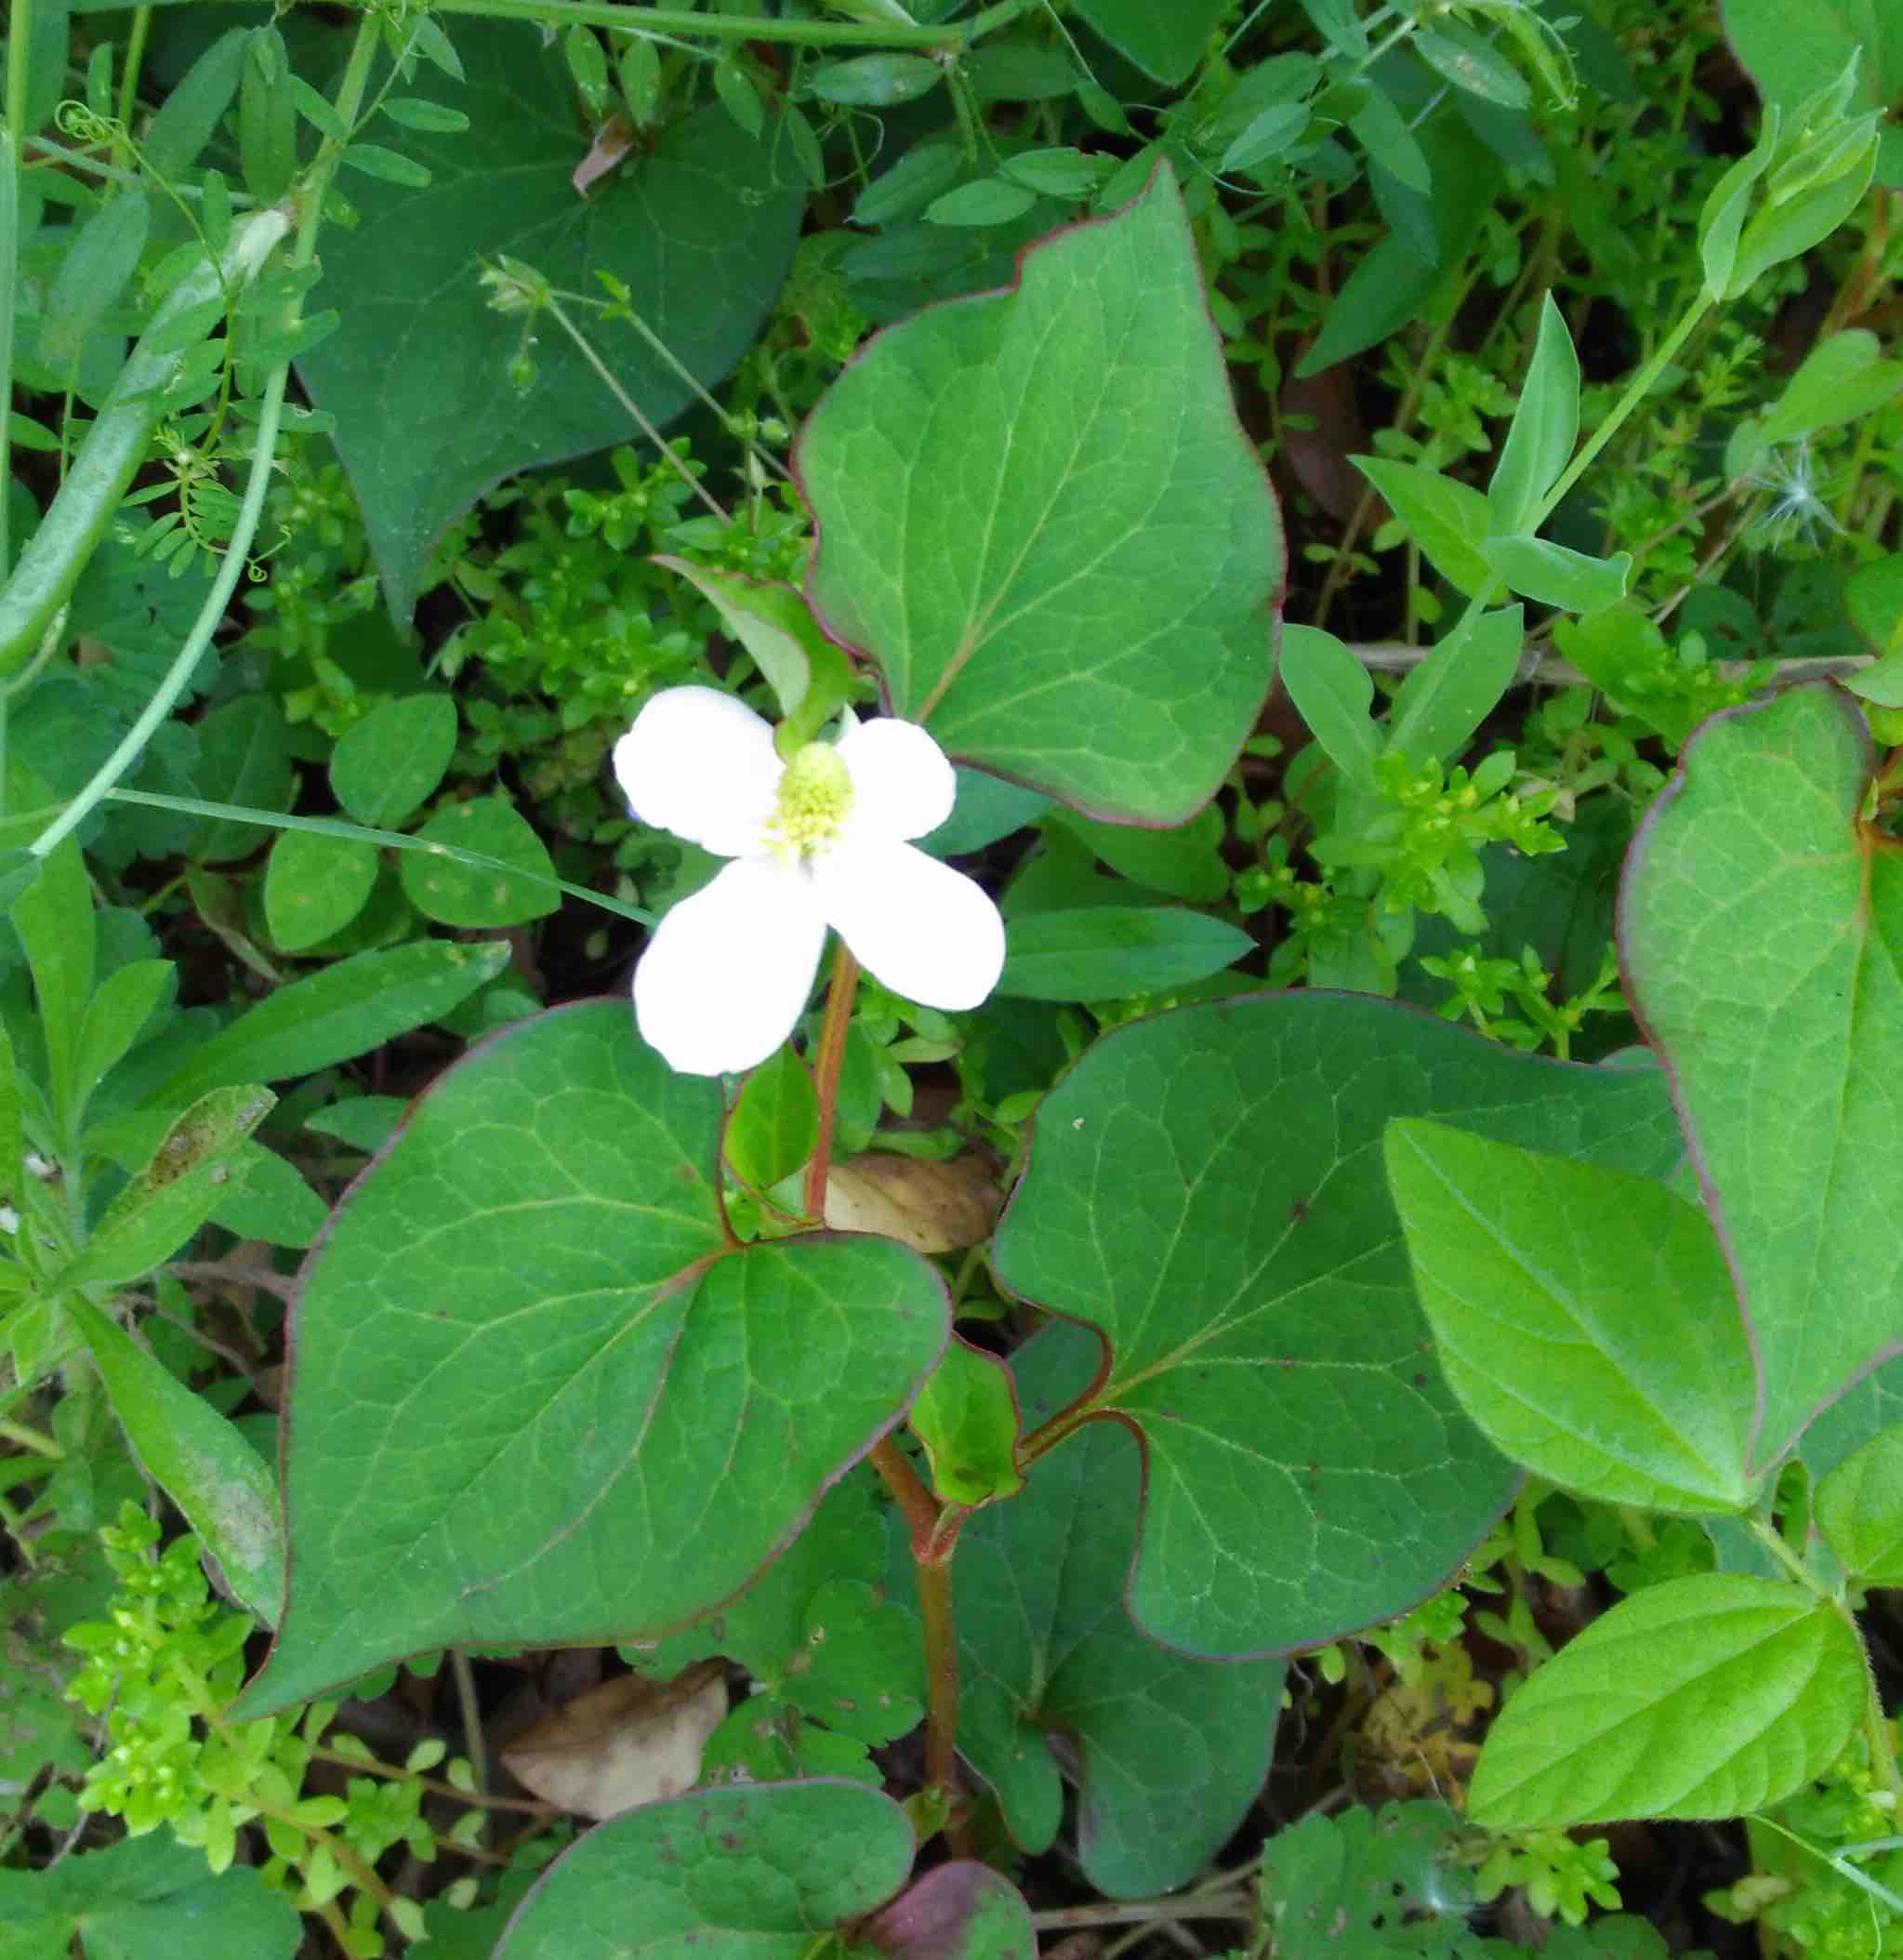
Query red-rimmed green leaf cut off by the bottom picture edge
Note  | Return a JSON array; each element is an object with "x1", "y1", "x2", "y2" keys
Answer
[{"x1": 494, "y1": 1778, "x2": 911, "y2": 1960}]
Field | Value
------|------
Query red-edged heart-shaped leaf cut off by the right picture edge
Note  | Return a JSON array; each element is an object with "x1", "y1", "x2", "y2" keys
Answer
[{"x1": 1619, "y1": 684, "x2": 1903, "y2": 1466}]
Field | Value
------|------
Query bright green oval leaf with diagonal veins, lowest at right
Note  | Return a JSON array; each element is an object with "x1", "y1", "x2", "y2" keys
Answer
[{"x1": 1468, "y1": 1572, "x2": 1866, "y2": 1831}]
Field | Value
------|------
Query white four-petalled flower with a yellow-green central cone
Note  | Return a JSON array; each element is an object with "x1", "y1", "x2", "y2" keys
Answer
[{"x1": 615, "y1": 688, "x2": 1003, "y2": 1076}]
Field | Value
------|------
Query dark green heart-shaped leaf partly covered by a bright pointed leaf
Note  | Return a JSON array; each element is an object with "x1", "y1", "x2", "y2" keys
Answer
[{"x1": 996, "y1": 992, "x2": 1682, "y2": 1654}]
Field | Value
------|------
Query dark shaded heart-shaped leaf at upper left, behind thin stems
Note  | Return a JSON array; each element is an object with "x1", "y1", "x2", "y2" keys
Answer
[{"x1": 297, "y1": 20, "x2": 805, "y2": 621}]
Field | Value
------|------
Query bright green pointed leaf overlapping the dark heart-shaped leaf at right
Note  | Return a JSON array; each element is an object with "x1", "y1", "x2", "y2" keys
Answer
[{"x1": 1388, "y1": 1119, "x2": 1758, "y2": 1513}]
